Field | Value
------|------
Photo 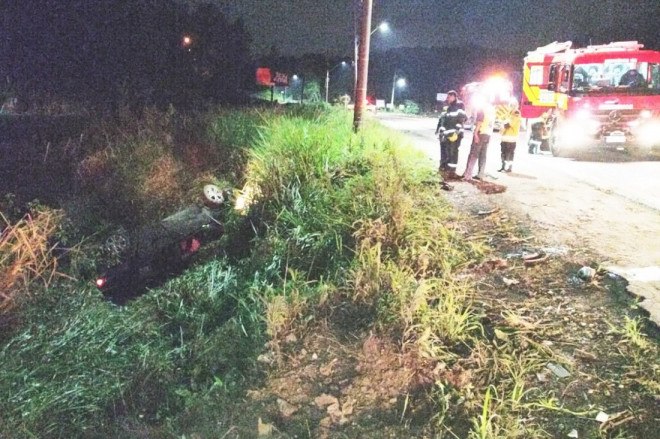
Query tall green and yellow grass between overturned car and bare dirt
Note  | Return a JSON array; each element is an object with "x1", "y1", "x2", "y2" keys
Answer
[{"x1": 0, "y1": 106, "x2": 488, "y2": 437}]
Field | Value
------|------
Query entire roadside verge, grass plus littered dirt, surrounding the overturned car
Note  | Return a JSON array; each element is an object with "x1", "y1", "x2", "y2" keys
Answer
[{"x1": 0, "y1": 106, "x2": 660, "y2": 439}]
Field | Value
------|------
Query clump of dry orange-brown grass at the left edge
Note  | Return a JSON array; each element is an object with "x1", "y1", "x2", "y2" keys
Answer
[{"x1": 0, "y1": 209, "x2": 62, "y2": 313}]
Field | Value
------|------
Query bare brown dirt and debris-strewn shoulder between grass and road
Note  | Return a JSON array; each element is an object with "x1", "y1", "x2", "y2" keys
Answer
[{"x1": 202, "y1": 183, "x2": 660, "y2": 439}]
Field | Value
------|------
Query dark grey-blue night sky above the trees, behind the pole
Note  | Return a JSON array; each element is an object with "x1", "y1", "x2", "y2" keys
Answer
[{"x1": 216, "y1": 0, "x2": 660, "y2": 55}]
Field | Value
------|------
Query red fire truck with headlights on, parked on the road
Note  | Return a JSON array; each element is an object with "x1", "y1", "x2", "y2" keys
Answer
[{"x1": 521, "y1": 41, "x2": 660, "y2": 155}]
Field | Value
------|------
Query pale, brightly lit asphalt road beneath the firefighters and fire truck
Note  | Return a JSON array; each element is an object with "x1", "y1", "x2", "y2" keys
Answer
[{"x1": 377, "y1": 113, "x2": 660, "y2": 324}]
